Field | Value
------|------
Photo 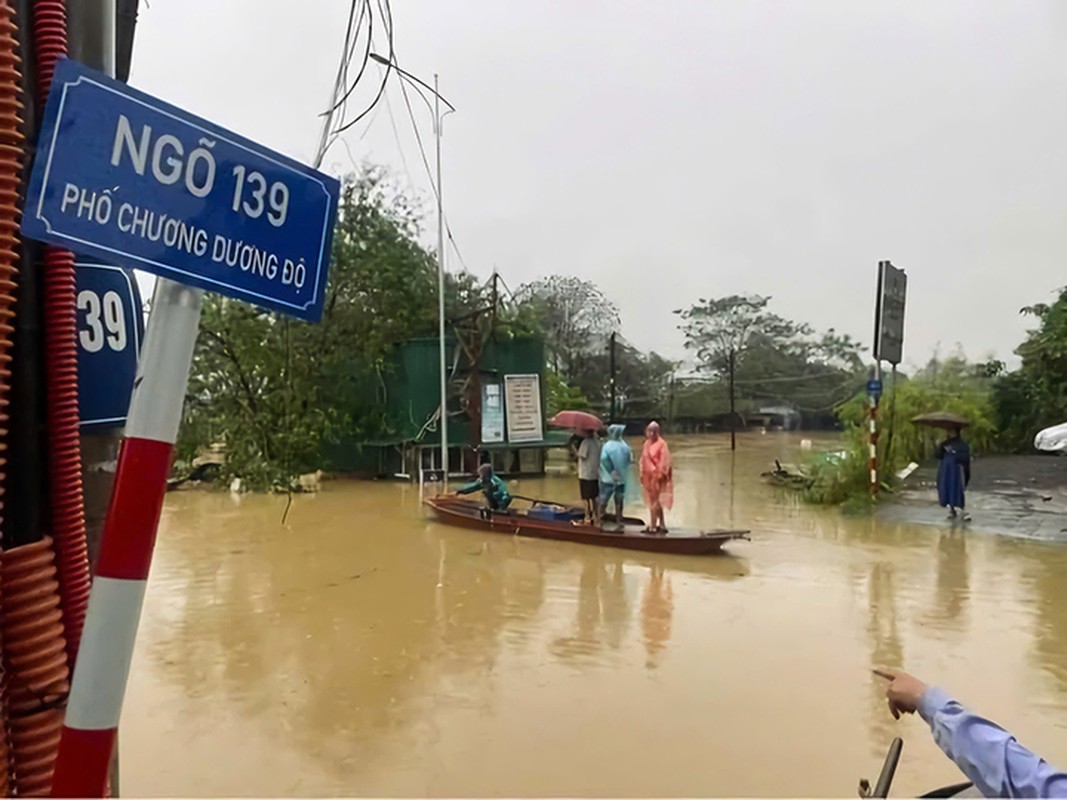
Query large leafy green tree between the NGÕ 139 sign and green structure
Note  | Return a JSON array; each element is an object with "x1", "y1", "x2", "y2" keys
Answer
[{"x1": 178, "y1": 167, "x2": 479, "y2": 489}]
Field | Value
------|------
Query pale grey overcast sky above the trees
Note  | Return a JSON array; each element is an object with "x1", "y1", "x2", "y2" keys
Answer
[{"x1": 130, "y1": 0, "x2": 1067, "y2": 373}]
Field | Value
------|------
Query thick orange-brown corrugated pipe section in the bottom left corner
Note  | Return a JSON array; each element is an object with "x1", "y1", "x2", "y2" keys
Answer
[{"x1": 0, "y1": 535, "x2": 70, "y2": 797}]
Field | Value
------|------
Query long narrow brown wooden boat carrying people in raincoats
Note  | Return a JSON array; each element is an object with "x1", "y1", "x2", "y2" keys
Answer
[{"x1": 426, "y1": 495, "x2": 749, "y2": 556}]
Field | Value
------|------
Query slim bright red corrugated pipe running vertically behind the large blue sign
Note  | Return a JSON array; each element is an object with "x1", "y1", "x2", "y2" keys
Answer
[{"x1": 33, "y1": 0, "x2": 91, "y2": 670}]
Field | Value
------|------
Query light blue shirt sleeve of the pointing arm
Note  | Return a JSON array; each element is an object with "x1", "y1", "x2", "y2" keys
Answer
[{"x1": 919, "y1": 687, "x2": 1067, "y2": 798}]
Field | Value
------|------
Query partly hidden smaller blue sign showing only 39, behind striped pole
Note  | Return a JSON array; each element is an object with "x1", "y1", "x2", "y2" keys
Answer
[{"x1": 76, "y1": 260, "x2": 144, "y2": 429}]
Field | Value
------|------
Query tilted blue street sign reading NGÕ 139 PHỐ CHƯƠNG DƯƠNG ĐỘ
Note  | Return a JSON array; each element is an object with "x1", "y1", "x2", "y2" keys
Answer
[{"x1": 22, "y1": 60, "x2": 340, "y2": 322}]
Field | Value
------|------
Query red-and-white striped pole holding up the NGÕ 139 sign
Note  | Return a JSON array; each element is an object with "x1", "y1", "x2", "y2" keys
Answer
[{"x1": 52, "y1": 278, "x2": 203, "y2": 797}]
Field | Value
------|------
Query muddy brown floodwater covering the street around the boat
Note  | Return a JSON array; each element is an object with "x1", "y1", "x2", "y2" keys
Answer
[{"x1": 120, "y1": 434, "x2": 1067, "y2": 797}]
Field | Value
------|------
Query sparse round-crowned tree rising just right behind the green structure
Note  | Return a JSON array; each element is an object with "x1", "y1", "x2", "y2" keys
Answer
[{"x1": 515, "y1": 275, "x2": 619, "y2": 382}]
